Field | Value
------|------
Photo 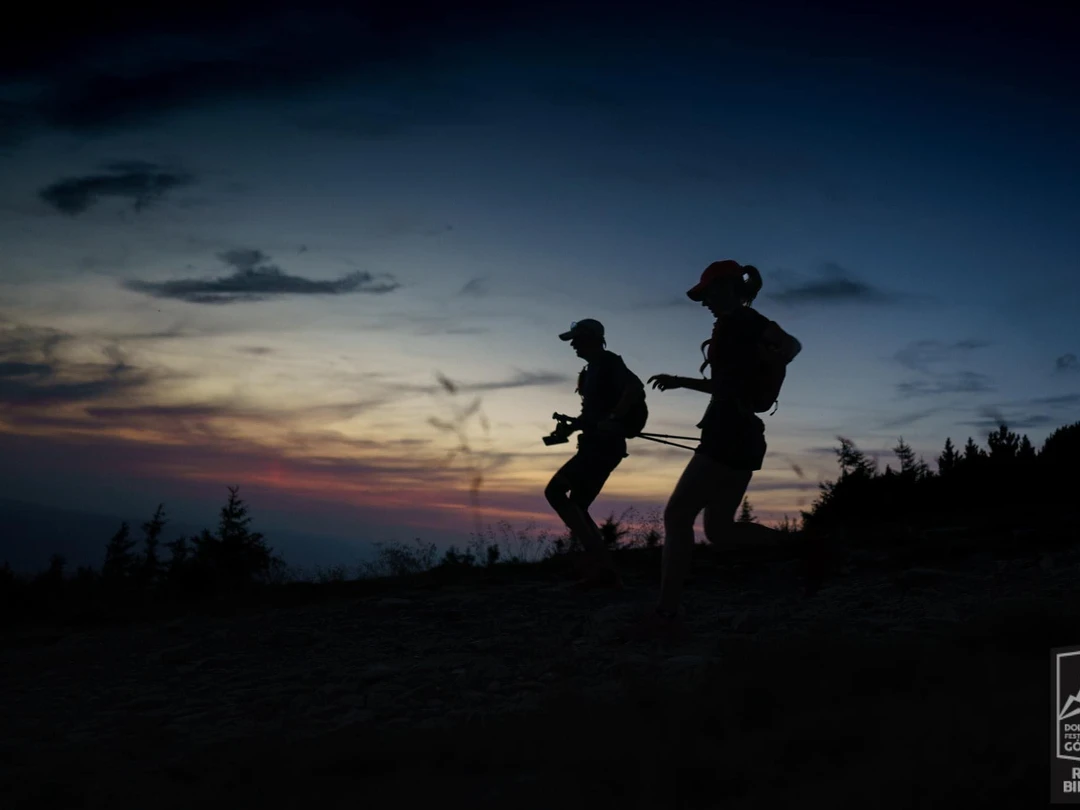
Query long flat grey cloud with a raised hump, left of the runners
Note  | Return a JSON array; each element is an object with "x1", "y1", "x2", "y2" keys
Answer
[{"x1": 124, "y1": 249, "x2": 401, "y2": 303}]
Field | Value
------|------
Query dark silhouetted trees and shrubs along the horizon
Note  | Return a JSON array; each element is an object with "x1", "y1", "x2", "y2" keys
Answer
[{"x1": 0, "y1": 422, "x2": 1080, "y2": 621}]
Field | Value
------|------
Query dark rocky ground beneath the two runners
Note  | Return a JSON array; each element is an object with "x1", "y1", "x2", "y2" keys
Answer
[{"x1": 0, "y1": 540, "x2": 1080, "y2": 808}]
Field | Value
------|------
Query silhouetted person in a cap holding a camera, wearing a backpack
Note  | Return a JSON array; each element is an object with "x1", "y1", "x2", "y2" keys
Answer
[{"x1": 544, "y1": 319, "x2": 645, "y2": 588}]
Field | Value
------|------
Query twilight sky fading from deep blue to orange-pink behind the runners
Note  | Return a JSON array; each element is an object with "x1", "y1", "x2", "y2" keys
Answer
[{"x1": 0, "y1": 0, "x2": 1080, "y2": 570}]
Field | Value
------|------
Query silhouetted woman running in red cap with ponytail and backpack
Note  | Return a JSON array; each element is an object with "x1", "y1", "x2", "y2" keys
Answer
[{"x1": 643, "y1": 259, "x2": 802, "y2": 634}]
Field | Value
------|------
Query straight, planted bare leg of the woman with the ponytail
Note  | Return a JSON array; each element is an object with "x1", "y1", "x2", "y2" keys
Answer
[{"x1": 657, "y1": 453, "x2": 720, "y2": 612}]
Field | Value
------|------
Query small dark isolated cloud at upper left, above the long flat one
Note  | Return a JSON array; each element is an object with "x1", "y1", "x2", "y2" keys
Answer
[{"x1": 39, "y1": 161, "x2": 193, "y2": 216}]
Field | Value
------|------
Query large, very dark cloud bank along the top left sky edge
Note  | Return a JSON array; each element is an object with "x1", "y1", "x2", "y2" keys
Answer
[{"x1": 0, "y1": 0, "x2": 521, "y2": 139}]
